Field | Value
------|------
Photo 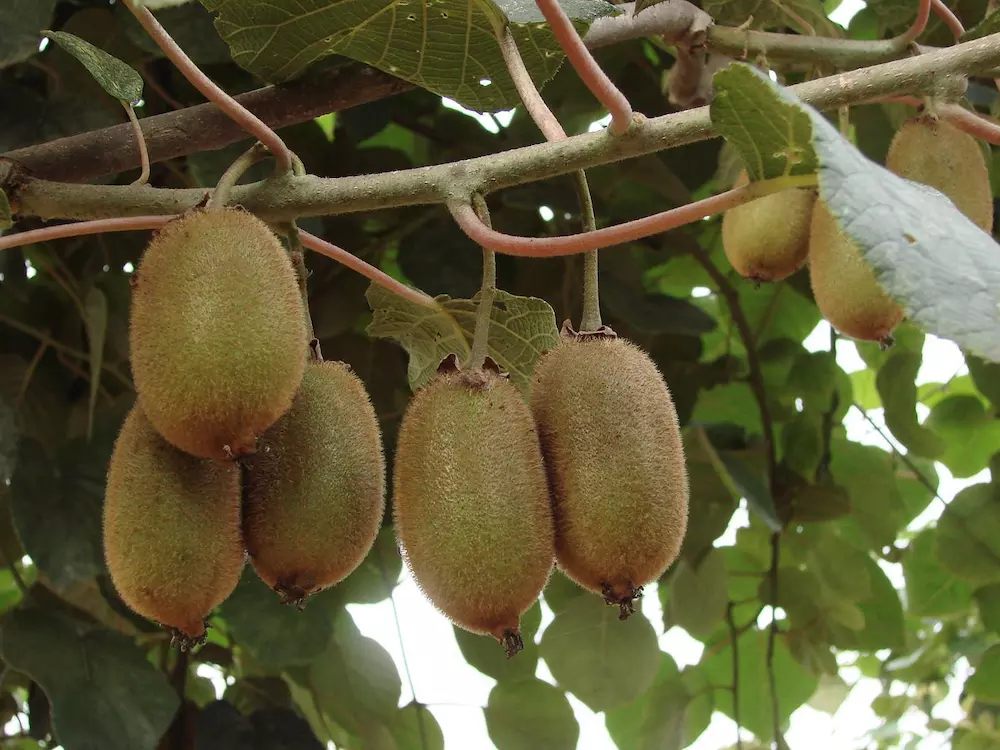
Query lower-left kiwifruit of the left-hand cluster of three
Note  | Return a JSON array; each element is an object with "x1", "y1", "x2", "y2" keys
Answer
[{"x1": 103, "y1": 406, "x2": 245, "y2": 646}]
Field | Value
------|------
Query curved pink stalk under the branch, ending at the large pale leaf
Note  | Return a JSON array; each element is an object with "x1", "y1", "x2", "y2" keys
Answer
[{"x1": 448, "y1": 185, "x2": 760, "y2": 258}]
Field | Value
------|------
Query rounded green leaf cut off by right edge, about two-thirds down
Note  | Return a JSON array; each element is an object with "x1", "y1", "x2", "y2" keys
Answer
[{"x1": 937, "y1": 484, "x2": 1000, "y2": 586}]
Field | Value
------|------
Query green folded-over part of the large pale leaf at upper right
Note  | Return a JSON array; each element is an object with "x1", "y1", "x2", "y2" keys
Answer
[{"x1": 705, "y1": 63, "x2": 817, "y2": 180}]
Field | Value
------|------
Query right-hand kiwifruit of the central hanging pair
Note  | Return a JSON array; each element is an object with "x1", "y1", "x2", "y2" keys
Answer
[{"x1": 531, "y1": 324, "x2": 688, "y2": 619}]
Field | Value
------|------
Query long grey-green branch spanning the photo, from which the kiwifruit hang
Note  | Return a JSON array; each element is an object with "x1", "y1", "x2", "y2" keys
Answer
[{"x1": 7, "y1": 34, "x2": 1000, "y2": 222}]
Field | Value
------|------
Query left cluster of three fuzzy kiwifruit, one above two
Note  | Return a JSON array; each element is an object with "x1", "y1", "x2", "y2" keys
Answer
[{"x1": 104, "y1": 208, "x2": 385, "y2": 646}]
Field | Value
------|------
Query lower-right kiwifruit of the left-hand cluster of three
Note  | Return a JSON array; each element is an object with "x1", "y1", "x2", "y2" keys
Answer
[{"x1": 243, "y1": 362, "x2": 385, "y2": 606}]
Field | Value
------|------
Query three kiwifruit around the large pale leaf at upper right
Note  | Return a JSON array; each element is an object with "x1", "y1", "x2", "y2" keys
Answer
[{"x1": 722, "y1": 113, "x2": 993, "y2": 344}]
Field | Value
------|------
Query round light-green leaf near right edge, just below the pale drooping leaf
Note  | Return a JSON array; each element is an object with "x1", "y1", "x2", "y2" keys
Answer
[{"x1": 924, "y1": 395, "x2": 1000, "y2": 479}]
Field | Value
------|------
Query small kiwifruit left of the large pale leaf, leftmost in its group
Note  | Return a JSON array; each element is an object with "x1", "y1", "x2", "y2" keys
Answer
[{"x1": 722, "y1": 170, "x2": 816, "y2": 282}]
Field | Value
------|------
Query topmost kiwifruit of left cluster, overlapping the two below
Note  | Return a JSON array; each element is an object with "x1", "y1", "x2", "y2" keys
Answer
[{"x1": 130, "y1": 208, "x2": 308, "y2": 459}]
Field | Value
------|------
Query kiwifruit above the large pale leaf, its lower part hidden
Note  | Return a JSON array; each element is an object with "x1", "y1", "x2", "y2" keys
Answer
[{"x1": 885, "y1": 114, "x2": 993, "y2": 233}]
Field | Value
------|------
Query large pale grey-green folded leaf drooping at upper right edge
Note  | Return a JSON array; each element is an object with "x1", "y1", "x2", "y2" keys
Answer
[{"x1": 713, "y1": 63, "x2": 1000, "y2": 362}]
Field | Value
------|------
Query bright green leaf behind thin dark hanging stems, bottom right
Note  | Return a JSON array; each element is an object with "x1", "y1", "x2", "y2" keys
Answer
[{"x1": 701, "y1": 629, "x2": 818, "y2": 742}]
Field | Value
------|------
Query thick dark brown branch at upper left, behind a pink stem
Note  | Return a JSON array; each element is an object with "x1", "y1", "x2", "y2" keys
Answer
[{"x1": 3, "y1": 65, "x2": 413, "y2": 182}]
